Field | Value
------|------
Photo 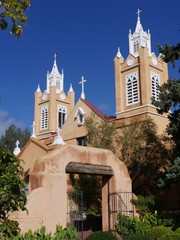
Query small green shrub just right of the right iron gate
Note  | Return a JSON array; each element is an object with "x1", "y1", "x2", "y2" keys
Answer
[{"x1": 131, "y1": 195, "x2": 155, "y2": 217}]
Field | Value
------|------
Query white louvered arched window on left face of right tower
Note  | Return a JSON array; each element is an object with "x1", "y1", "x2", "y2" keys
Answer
[{"x1": 126, "y1": 72, "x2": 139, "y2": 105}]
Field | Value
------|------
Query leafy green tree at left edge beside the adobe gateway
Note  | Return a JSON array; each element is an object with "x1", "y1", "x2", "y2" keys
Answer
[{"x1": 0, "y1": 147, "x2": 26, "y2": 239}]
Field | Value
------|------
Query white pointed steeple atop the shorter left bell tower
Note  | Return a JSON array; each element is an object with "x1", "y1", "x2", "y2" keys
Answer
[{"x1": 46, "y1": 53, "x2": 64, "y2": 93}]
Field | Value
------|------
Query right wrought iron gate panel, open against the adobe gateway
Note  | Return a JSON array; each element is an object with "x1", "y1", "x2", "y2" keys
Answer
[{"x1": 108, "y1": 191, "x2": 134, "y2": 231}]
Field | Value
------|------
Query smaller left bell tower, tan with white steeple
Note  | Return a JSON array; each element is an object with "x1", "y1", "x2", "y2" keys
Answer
[{"x1": 33, "y1": 54, "x2": 75, "y2": 144}]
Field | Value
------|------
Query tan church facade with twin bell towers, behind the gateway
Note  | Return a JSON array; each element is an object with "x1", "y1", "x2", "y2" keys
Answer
[{"x1": 30, "y1": 10, "x2": 168, "y2": 145}]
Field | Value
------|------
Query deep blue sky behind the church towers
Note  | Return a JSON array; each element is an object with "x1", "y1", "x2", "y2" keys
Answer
[{"x1": 0, "y1": 0, "x2": 180, "y2": 135}]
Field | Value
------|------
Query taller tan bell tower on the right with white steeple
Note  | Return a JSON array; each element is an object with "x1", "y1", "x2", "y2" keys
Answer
[{"x1": 114, "y1": 9, "x2": 168, "y2": 132}]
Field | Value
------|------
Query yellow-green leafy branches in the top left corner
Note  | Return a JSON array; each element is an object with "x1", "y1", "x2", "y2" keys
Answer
[{"x1": 0, "y1": 0, "x2": 30, "y2": 37}]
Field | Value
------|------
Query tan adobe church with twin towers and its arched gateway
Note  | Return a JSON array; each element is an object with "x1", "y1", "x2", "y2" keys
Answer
[{"x1": 13, "y1": 10, "x2": 168, "y2": 231}]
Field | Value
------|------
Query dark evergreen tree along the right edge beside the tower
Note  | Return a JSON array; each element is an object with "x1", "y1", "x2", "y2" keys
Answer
[{"x1": 152, "y1": 41, "x2": 180, "y2": 187}]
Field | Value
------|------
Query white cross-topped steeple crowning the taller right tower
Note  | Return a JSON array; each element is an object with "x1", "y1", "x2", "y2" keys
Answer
[{"x1": 129, "y1": 9, "x2": 151, "y2": 57}]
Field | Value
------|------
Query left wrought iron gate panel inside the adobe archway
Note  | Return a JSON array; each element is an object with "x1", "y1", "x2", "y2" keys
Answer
[{"x1": 67, "y1": 191, "x2": 86, "y2": 240}]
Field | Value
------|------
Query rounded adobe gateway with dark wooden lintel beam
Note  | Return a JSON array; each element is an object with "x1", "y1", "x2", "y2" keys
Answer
[{"x1": 12, "y1": 145, "x2": 132, "y2": 232}]
